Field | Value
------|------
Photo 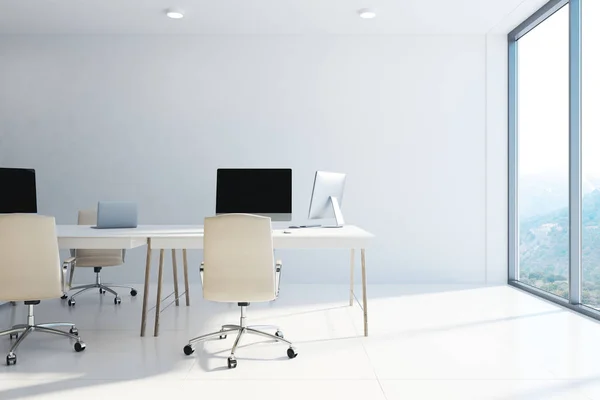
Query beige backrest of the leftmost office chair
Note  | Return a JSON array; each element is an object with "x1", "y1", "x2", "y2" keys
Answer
[{"x1": 0, "y1": 214, "x2": 63, "y2": 301}]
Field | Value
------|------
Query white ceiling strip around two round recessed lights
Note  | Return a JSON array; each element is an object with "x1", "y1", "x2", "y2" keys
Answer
[{"x1": 0, "y1": 0, "x2": 543, "y2": 35}]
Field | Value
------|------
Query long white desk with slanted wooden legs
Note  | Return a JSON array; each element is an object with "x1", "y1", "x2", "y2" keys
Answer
[{"x1": 57, "y1": 225, "x2": 373, "y2": 336}]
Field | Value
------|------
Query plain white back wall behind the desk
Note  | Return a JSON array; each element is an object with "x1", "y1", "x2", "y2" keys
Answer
[{"x1": 0, "y1": 35, "x2": 506, "y2": 283}]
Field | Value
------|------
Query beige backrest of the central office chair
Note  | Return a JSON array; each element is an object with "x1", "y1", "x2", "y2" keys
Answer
[{"x1": 203, "y1": 214, "x2": 276, "y2": 302}]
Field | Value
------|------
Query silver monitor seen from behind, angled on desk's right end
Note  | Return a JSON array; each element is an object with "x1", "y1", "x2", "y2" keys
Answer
[{"x1": 308, "y1": 171, "x2": 346, "y2": 228}]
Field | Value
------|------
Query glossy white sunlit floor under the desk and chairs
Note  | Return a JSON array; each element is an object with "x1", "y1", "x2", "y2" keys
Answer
[{"x1": 0, "y1": 285, "x2": 600, "y2": 400}]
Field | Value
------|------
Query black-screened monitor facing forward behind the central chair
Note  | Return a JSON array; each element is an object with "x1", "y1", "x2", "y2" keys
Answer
[{"x1": 216, "y1": 168, "x2": 292, "y2": 221}]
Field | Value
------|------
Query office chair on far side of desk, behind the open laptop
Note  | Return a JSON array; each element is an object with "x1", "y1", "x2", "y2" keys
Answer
[{"x1": 62, "y1": 209, "x2": 137, "y2": 306}]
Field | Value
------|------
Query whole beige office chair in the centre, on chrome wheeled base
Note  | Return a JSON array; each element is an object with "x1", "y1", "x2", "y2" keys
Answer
[{"x1": 183, "y1": 214, "x2": 298, "y2": 368}]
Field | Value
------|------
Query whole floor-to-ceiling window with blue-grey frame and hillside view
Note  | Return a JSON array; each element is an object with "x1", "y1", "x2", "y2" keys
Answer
[{"x1": 508, "y1": 0, "x2": 600, "y2": 319}]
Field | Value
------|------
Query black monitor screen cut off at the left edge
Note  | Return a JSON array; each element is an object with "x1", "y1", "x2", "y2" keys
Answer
[{"x1": 0, "y1": 168, "x2": 37, "y2": 214}]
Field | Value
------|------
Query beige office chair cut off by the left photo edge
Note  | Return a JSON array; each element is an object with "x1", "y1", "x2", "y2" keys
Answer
[{"x1": 0, "y1": 214, "x2": 85, "y2": 365}]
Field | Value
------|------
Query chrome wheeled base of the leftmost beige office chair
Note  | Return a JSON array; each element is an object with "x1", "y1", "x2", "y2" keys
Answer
[{"x1": 0, "y1": 305, "x2": 86, "y2": 365}]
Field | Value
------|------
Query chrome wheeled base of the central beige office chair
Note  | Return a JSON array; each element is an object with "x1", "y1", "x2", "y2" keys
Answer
[{"x1": 183, "y1": 306, "x2": 298, "y2": 368}]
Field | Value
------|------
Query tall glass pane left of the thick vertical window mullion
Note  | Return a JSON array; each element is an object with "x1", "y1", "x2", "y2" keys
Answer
[{"x1": 517, "y1": 5, "x2": 569, "y2": 298}]
